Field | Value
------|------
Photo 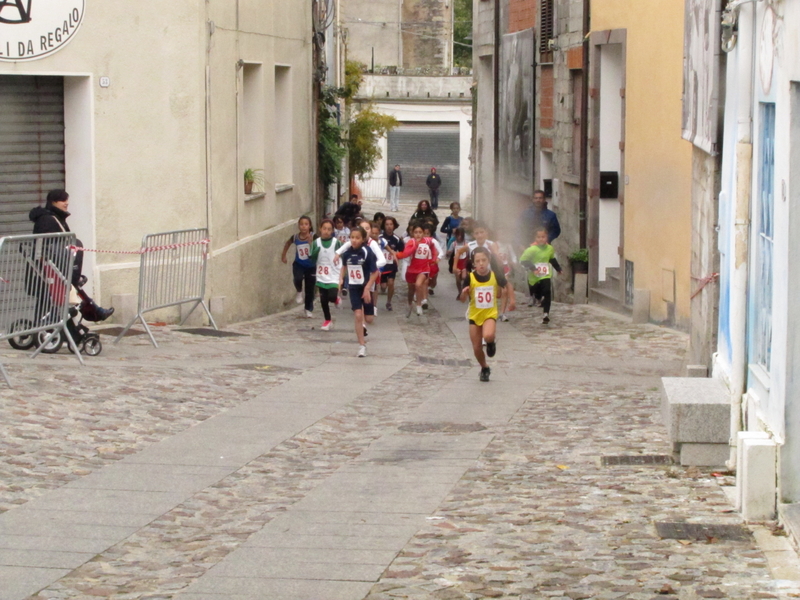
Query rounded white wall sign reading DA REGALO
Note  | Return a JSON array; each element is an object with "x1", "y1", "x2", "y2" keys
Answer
[{"x1": 0, "y1": 0, "x2": 85, "y2": 62}]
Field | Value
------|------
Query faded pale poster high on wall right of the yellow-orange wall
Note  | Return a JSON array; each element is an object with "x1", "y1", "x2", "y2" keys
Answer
[{"x1": 683, "y1": 0, "x2": 722, "y2": 154}]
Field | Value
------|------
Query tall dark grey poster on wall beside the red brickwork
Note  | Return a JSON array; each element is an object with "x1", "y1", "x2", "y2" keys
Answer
[{"x1": 499, "y1": 29, "x2": 534, "y2": 195}]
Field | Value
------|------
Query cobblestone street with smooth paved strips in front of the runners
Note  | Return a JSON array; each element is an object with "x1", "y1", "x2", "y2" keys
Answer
[{"x1": 0, "y1": 269, "x2": 800, "y2": 600}]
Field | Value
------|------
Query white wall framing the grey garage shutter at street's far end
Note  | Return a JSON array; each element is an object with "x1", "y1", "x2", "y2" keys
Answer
[{"x1": 372, "y1": 102, "x2": 472, "y2": 204}]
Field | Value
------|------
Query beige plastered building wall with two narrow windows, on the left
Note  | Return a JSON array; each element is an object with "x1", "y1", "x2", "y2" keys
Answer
[{"x1": 0, "y1": 0, "x2": 316, "y2": 326}]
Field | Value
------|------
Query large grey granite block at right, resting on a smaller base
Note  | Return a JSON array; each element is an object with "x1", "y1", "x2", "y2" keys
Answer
[{"x1": 661, "y1": 377, "x2": 731, "y2": 446}]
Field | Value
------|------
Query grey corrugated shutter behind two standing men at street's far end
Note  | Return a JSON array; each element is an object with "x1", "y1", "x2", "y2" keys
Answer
[{"x1": 387, "y1": 123, "x2": 461, "y2": 205}]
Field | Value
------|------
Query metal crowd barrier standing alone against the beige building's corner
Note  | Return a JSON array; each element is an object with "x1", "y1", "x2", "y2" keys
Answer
[{"x1": 114, "y1": 229, "x2": 218, "y2": 348}]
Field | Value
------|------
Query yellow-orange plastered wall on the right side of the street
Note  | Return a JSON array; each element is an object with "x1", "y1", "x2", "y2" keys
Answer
[{"x1": 592, "y1": 0, "x2": 692, "y2": 326}]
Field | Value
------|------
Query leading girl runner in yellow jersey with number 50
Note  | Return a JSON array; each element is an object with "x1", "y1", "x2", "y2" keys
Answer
[{"x1": 458, "y1": 248, "x2": 516, "y2": 381}]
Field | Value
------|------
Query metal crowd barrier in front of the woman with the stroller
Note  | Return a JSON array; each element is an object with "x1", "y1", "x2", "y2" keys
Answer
[{"x1": 0, "y1": 233, "x2": 83, "y2": 387}]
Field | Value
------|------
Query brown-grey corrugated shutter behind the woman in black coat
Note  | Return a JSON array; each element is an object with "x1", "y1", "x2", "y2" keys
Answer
[{"x1": 0, "y1": 75, "x2": 65, "y2": 235}]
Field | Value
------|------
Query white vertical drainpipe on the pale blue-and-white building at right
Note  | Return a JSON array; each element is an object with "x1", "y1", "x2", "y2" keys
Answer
[{"x1": 728, "y1": 3, "x2": 756, "y2": 461}]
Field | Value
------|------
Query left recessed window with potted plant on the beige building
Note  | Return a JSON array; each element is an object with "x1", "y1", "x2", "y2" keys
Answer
[{"x1": 239, "y1": 63, "x2": 266, "y2": 192}]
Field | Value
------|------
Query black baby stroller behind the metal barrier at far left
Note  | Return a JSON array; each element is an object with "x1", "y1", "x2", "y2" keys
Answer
[{"x1": 8, "y1": 287, "x2": 103, "y2": 356}]
